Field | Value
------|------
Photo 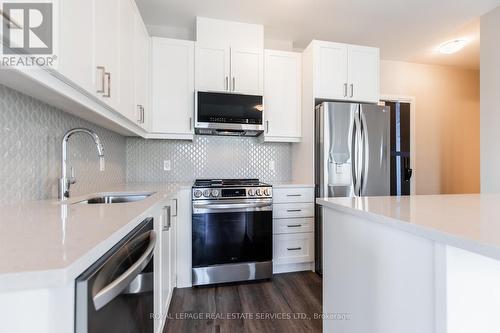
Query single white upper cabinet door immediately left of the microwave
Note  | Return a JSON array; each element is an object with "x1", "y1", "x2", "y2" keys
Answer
[{"x1": 151, "y1": 37, "x2": 194, "y2": 134}]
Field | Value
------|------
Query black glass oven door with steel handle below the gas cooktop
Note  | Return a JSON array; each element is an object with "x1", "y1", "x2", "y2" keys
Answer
[{"x1": 192, "y1": 200, "x2": 273, "y2": 268}]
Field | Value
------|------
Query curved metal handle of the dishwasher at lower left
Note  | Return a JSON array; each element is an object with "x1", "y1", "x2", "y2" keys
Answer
[{"x1": 93, "y1": 230, "x2": 156, "y2": 311}]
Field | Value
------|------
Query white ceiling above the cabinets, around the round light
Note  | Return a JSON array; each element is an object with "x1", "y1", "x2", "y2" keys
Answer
[{"x1": 137, "y1": 0, "x2": 500, "y2": 68}]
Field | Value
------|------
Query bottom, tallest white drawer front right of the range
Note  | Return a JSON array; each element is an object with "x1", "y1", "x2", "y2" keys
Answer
[{"x1": 273, "y1": 232, "x2": 314, "y2": 265}]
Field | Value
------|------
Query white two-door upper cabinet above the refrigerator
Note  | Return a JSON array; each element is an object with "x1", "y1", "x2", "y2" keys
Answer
[{"x1": 310, "y1": 41, "x2": 380, "y2": 103}]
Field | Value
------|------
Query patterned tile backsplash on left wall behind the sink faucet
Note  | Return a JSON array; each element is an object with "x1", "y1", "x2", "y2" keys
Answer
[{"x1": 0, "y1": 83, "x2": 126, "y2": 204}]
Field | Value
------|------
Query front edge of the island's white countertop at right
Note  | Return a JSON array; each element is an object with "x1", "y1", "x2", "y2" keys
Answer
[{"x1": 316, "y1": 198, "x2": 500, "y2": 260}]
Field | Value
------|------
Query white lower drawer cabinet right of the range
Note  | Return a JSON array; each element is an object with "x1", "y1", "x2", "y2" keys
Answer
[{"x1": 273, "y1": 185, "x2": 314, "y2": 273}]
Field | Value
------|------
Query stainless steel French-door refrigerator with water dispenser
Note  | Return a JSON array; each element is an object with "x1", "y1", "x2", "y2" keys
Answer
[{"x1": 315, "y1": 102, "x2": 391, "y2": 274}]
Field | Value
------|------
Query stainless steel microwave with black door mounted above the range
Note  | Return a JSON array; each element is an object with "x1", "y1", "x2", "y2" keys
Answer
[{"x1": 195, "y1": 91, "x2": 264, "y2": 136}]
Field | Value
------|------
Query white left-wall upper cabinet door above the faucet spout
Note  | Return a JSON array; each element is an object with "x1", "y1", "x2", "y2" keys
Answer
[{"x1": 94, "y1": 0, "x2": 120, "y2": 109}]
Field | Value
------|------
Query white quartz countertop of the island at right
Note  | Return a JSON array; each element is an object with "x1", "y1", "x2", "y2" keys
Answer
[{"x1": 316, "y1": 194, "x2": 500, "y2": 260}]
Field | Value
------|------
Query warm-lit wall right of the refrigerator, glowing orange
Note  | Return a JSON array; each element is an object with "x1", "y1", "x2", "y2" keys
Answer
[{"x1": 380, "y1": 60, "x2": 480, "y2": 194}]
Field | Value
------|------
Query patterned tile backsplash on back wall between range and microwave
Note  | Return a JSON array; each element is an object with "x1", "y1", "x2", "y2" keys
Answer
[{"x1": 127, "y1": 136, "x2": 292, "y2": 182}]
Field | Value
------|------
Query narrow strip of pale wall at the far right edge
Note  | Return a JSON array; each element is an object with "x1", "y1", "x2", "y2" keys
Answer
[{"x1": 481, "y1": 7, "x2": 500, "y2": 192}]
